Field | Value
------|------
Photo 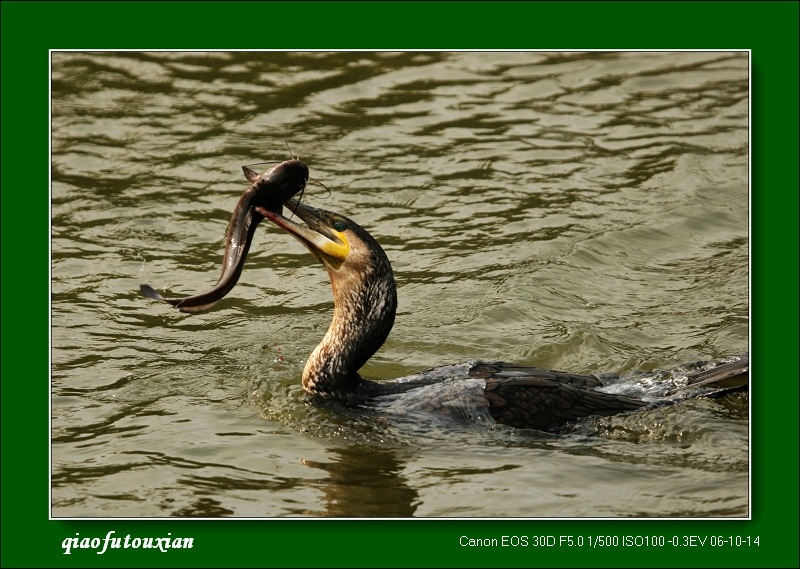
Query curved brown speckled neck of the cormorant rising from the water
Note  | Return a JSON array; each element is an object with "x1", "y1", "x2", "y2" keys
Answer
[{"x1": 303, "y1": 243, "x2": 397, "y2": 401}]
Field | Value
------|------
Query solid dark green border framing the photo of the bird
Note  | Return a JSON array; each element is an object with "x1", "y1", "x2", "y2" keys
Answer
[{"x1": 0, "y1": 2, "x2": 800, "y2": 567}]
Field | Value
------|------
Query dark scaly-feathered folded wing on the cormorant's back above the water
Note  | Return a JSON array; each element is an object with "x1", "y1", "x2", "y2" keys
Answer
[{"x1": 470, "y1": 364, "x2": 648, "y2": 431}]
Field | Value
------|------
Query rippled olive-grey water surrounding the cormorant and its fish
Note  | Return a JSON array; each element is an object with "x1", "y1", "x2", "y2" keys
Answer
[{"x1": 52, "y1": 52, "x2": 749, "y2": 517}]
